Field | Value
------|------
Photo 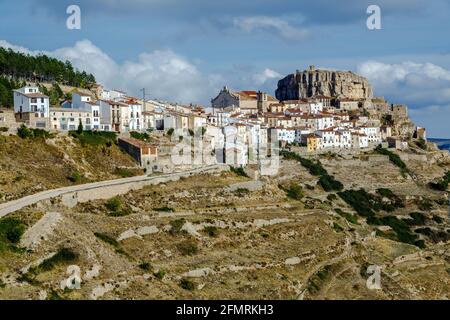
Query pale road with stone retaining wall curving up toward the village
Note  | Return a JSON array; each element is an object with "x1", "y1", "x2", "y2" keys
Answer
[{"x1": 0, "y1": 164, "x2": 228, "y2": 218}]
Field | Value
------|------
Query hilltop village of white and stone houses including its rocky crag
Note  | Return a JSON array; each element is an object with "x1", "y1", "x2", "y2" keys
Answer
[{"x1": 0, "y1": 66, "x2": 426, "y2": 172}]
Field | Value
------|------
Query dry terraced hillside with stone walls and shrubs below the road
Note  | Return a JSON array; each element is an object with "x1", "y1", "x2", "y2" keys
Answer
[{"x1": 0, "y1": 145, "x2": 450, "y2": 299}]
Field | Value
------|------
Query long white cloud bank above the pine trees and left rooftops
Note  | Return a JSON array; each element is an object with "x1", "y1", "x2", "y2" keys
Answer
[{"x1": 0, "y1": 40, "x2": 281, "y2": 106}]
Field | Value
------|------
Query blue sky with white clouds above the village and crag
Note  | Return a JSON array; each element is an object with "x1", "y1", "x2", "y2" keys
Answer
[{"x1": 0, "y1": 0, "x2": 450, "y2": 138}]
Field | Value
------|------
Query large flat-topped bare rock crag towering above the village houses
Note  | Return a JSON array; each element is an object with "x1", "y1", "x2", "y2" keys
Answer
[{"x1": 276, "y1": 66, "x2": 373, "y2": 101}]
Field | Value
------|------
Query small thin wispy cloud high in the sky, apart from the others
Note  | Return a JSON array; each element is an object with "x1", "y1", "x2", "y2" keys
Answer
[{"x1": 233, "y1": 16, "x2": 309, "y2": 41}]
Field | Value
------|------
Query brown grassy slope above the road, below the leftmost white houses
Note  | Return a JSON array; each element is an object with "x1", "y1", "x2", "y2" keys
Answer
[{"x1": 0, "y1": 135, "x2": 142, "y2": 203}]
